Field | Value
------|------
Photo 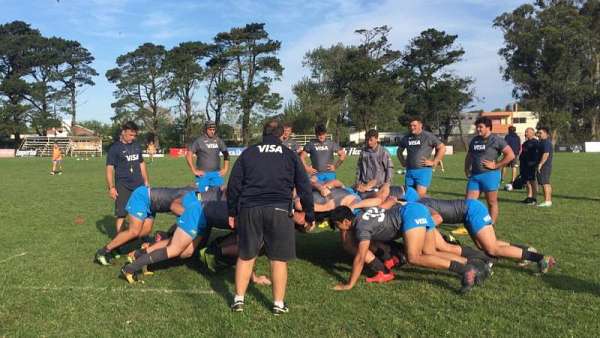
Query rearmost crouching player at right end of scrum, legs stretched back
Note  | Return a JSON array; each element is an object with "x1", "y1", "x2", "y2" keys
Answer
[{"x1": 419, "y1": 198, "x2": 556, "y2": 273}]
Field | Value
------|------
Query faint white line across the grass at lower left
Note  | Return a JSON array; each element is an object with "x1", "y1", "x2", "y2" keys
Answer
[{"x1": 0, "y1": 285, "x2": 215, "y2": 295}]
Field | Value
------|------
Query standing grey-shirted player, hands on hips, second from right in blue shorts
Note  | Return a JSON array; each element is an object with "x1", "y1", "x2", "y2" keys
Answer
[{"x1": 397, "y1": 117, "x2": 446, "y2": 197}]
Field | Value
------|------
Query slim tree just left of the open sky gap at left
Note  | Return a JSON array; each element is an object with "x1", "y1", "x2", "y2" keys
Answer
[{"x1": 56, "y1": 40, "x2": 98, "y2": 126}]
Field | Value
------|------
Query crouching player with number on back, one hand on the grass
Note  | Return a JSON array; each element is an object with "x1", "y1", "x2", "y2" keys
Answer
[{"x1": 330, "y1": 203, "x2": 485, "y2": 292}]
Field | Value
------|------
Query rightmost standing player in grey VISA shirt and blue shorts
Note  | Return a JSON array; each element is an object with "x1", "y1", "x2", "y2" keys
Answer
[{"x1": 465, "y1": 117, "x2": 515, "y2": 223}]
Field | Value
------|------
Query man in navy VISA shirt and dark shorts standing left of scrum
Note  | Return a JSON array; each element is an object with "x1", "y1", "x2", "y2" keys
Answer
[{"x1": 106, "y1": 121, "x2": 150, "y2": 233}]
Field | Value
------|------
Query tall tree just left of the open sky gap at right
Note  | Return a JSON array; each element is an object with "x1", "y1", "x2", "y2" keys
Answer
[{"x1": 402, "y1": 28, "x2": 474, "y2": 142}]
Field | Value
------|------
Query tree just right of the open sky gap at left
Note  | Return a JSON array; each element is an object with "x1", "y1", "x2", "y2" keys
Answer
[{"x1": 106, "y1": 43, "x2": 170, "y2": 147}]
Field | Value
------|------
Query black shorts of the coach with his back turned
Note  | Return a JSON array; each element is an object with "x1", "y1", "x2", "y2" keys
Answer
[{"x1": 237, "y1": 206, "x2": 296, "y2": 262}]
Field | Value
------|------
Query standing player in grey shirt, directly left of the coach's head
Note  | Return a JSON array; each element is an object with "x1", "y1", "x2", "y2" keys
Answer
[{"x1": 185, "y1": 121, "x2": 229, "y2": 192}]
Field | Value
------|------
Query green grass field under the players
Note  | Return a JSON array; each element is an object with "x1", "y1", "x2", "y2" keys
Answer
[{"x1": 0, "y1": 154, "x2": 600, "y2": 337}]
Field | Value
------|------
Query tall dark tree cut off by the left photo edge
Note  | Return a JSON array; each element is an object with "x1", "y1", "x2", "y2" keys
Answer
[{"x1": 0, "y1": 21, "x2": 41, "y2": 146}]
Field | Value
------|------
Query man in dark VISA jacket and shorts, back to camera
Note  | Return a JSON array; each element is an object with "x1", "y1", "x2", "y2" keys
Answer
[{"x1": 227, "y1": 120, "x2": 314, "y2": 314}]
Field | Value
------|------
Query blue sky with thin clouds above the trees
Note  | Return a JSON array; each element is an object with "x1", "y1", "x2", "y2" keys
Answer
[{"x1": 0, "y1": 0, "x2": 524, "y2": 121}]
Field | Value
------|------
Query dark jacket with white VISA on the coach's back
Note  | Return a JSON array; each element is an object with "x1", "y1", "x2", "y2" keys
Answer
[{"x1": 227, "y1": 136, "x2": 314, "y2": 222}]
